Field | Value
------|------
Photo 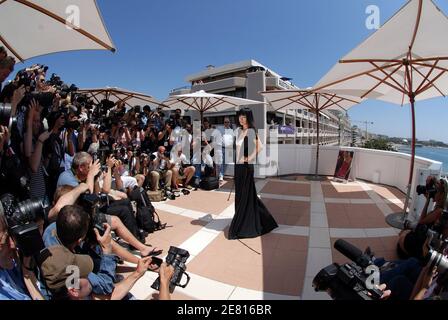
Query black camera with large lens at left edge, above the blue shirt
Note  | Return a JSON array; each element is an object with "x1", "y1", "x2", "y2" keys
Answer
[{"x1": 0, "y1": 194, "x2": 48, "y2": 257}]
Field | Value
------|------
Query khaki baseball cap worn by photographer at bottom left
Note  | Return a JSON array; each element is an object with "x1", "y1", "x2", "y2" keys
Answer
[{"x1": 39, "y1": 246, "x2": 93, "y2": 291}]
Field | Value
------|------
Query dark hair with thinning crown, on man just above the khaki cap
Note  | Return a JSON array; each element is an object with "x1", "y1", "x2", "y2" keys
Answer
[{"x1": 56, "y1": 205, "x2": 90, "y2": 248}]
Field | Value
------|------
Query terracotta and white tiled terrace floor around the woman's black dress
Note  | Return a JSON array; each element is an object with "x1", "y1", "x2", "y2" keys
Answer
[{"x1": 121, "y1": 176, "x2": 405, "y2": 300}]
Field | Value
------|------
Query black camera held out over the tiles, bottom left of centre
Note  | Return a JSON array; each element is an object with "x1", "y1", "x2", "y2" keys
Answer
[{"x1": 151, "y1": 247, "x2": 190, "y2": 293}]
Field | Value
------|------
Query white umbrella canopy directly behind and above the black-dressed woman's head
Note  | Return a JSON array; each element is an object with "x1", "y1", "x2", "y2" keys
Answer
[{"x1": 163, "y1": 90, "x2": 264, "y2": 122}]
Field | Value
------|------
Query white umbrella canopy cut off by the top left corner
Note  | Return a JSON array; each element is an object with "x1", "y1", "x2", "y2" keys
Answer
[{"x1": 0, "y1": 0, "x2": 115, "y2": 62}]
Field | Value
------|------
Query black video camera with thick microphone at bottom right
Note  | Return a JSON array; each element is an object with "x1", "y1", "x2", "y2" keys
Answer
[{"x1": 313, "y1": 240, "x2": 383, "y2": 300}]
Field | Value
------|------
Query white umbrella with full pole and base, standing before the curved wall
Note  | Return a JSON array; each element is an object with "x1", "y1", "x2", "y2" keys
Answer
[{"x1": 261, "y1": 89, "x2": 362, "y2": 181}]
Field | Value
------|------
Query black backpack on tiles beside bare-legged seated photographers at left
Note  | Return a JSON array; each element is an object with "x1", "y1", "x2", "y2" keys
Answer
[{"x1": 131, "y1": 188, "x2": 166, "y2": 233}]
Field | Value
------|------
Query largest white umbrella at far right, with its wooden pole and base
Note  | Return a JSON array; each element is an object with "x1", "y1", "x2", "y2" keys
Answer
[{"x1": 317, "y1": 0, "x2": 448, "y2": 228}]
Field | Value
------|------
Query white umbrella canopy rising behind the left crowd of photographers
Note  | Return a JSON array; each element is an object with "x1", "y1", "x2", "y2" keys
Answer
[{"x1": 78, "y1": 87, "x2": 161, "y2": 108}]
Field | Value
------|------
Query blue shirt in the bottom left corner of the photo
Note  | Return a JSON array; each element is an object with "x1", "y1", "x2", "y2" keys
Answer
[{"x1": 0, "y1": 265, "x2": 31, "y2": 300}]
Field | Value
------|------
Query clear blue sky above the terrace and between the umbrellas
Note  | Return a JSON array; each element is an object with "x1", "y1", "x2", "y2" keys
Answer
[{"x1": 8, "y1": 0, "x2": 448, "y2": 142}]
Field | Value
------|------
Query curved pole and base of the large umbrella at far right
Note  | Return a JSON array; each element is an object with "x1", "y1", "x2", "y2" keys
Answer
[{"x1": 386, "y1": 94, "x2": 416, "y2": 229}]
